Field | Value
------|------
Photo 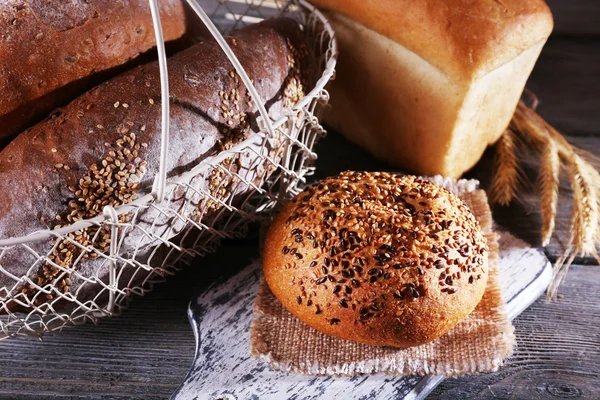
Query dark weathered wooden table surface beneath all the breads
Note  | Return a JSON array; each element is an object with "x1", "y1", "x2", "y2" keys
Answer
[{"x1": 0, "y1": 0, "x2": 600, "y2": 399}]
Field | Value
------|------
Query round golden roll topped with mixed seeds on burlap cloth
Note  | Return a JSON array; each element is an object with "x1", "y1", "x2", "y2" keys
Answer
[{"x1": 263, "y1": 172, "x2": 488, "y2": 348}]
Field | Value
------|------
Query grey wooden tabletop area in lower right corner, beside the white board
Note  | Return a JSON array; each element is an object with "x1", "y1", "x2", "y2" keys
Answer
[{"x1": 430, "y1": 266, "x2": 600, "y2": 399}]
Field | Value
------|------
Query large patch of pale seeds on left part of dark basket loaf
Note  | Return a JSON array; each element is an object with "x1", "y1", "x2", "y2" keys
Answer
[{"x1": 18, "y1": 133, "x2": 148, "y2": 306}]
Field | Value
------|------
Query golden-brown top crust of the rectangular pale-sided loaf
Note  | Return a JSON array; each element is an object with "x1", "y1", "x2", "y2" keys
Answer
[{"x1": 311, "y1": 0, "x2": 553, "y2": 81}]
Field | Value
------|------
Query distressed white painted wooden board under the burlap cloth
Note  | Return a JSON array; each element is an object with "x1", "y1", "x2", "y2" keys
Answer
[{"x1": 172, "y1": 233, "x2": 552, "y2": 400}]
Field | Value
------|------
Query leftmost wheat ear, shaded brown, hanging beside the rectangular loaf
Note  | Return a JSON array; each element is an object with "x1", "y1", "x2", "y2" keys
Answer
[{"x1": 490, "y1": 129, "x2": 522, "y2": 206}]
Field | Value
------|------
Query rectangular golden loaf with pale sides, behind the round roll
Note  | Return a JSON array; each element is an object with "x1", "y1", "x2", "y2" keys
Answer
[{"x1": 312, "y1": 0, "x2": 552, "y2": 177}]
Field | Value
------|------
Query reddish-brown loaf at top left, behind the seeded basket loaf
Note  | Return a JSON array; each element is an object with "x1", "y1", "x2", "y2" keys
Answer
[{"x1": 0, "y1": 0, "x2": 186, "y2": 139}]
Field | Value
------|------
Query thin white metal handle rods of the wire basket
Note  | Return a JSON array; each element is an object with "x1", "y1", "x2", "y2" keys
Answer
[{"x1": 149, "y1": 0, "x2": 275, "y2": 203}]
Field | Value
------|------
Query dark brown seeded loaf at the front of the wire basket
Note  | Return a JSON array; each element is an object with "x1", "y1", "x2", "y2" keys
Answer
[{"x1": 0, "y1": 19, "x2": 316, "y2": 310}]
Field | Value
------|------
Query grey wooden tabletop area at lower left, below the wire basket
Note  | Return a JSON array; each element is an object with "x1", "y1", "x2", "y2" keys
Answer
[{"x1": 0, "y1": 243, "x2": 258, "y2": 400}]
